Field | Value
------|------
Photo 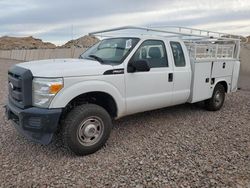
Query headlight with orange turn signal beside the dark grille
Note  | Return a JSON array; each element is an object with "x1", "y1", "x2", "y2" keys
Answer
[{"x1": 32, "y1": 78, "x2": 63, "y2": 108}]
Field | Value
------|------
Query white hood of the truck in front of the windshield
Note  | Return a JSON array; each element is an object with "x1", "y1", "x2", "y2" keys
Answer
[{"x1": 17, "y1": 59, "x2": 113, "y2": 77}]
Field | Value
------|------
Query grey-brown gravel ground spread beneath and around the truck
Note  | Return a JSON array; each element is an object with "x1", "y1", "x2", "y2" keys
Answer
[{"x1": 0, "y1": 60, "x2": 250, "y2": 187}]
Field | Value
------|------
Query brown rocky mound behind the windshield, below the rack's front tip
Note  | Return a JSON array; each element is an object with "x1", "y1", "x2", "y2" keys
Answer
[{"x1": 60, "y1": 35, "x2": 100, "y2": 48}]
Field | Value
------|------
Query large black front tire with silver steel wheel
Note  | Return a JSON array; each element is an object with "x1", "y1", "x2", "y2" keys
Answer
[{"x1": 62, "y1": 104, "x2": 112, "y2": 156}]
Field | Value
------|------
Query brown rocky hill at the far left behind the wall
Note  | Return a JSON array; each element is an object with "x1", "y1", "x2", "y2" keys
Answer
[{"x1": 0, "y1": 36, "x2": 56, "y2": 50}]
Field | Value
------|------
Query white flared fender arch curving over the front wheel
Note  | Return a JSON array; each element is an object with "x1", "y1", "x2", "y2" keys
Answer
[{"x1": 49, "y1": 80, "x2": 126, "y2": 117}]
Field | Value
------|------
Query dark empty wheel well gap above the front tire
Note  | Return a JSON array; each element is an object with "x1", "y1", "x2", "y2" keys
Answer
[{"x1": 65, "y1": 92, "x2": 117, "y2": 118}]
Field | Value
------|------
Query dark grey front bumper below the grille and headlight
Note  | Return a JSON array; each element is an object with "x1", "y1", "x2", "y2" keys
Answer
[{"x1": 6, "y1": 102, "x2": 62, "y2": 145}]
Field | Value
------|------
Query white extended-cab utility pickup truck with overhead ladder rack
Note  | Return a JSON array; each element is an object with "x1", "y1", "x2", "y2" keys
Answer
[{"x1": 6, "y1": 27, "x2": 245, "y2": 155}]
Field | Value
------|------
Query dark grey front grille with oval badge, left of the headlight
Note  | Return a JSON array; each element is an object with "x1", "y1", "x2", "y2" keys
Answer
[{"x1": 8, "y1": 66, "x2": 33, "y2": 109}]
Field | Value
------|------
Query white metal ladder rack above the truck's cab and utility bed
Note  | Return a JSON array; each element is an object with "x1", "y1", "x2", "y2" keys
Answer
[{"x1": 89, "y1": 26, "x2": 248, "y2": 60}]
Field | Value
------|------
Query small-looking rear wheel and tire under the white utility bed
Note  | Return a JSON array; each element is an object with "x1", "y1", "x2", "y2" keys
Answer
[{"x1": 205, "y1": 84, "x2": 225, "y2": 111}]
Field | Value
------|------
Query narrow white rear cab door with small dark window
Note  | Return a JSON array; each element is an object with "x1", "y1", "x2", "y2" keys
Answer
[{"x1": 169, "y1": 41, "x2": 192, "y2": 105}]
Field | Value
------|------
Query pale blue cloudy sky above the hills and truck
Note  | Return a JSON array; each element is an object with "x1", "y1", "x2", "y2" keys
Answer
[{"x1": 0, "y1": 0, "x2": 250, "y2": 44}]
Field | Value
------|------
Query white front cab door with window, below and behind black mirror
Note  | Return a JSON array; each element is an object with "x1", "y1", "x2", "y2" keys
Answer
[{"x1": 125, "y1": 40, "x2": 173, "y2": 114}]
